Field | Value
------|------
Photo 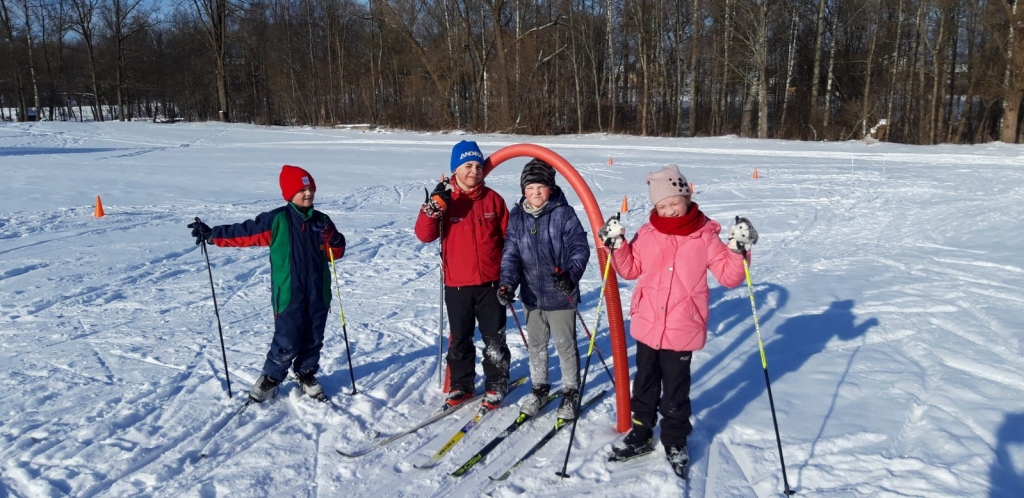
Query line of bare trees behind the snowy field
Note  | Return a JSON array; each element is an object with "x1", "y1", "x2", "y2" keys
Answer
[{"x1": 0, "y1": 0, "x2": 1024, "y2": 144}]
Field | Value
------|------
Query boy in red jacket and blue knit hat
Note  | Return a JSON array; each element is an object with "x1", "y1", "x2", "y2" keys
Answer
[{"x1": 416, "y1": 140, "x2": 511, "y2": 409}]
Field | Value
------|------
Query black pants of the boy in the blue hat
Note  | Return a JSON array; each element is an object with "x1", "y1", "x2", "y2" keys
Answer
[{"x1": 444, "y1": 282, "x2": 512, "y2": 393}]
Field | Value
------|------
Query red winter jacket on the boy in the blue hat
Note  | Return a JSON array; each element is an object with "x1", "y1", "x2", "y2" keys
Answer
[{"x1": 416, "y1": 181, "x2": 509, "y2": 287}]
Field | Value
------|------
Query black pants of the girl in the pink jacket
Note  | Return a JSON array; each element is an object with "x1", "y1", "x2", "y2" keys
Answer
[{"x1": 630, "y1": 342, "x2": 693, "y2": 447}]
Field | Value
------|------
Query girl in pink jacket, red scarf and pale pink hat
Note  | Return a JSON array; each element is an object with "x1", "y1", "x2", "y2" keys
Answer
[{"x1": 598, "y1": 164, "x2": 757, "y2": 478}]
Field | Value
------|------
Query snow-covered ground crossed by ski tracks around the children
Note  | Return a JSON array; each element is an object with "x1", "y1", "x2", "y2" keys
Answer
[{"x1": 0, "y1": 122, "x2": 1024, "y2": 497}]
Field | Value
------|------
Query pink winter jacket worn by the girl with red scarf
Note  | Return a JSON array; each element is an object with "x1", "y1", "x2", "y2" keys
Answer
[{"x1": 612, "y1": 218, "x2": 750, "y2": 351}]
